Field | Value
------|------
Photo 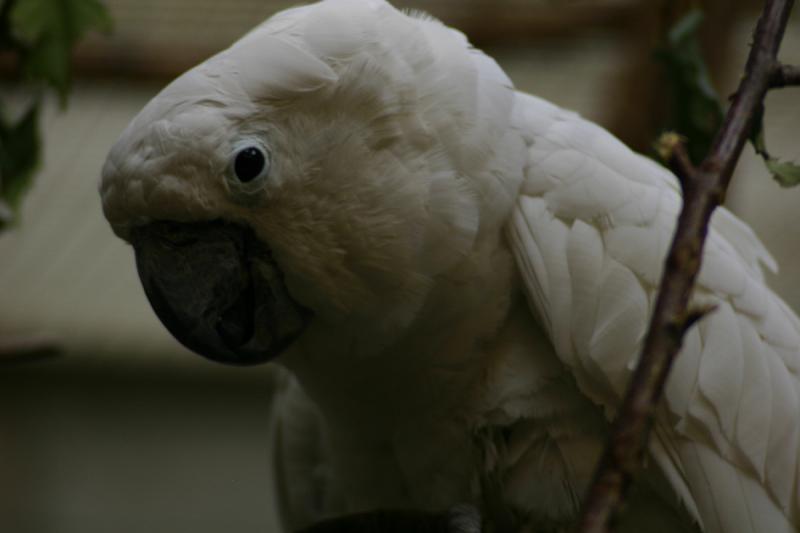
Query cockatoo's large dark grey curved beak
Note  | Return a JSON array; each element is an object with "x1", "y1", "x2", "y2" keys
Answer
[{"x1": 131, "y1": 221, "x2": 310, "y2": 365}]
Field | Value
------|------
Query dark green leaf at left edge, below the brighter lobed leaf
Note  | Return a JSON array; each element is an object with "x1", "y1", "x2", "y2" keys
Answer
[{"x1": 0, "y1": 103, "x2": 41, "y2": 217}]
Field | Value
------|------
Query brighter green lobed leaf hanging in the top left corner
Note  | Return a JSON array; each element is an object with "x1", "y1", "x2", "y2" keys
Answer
[{"x1": 10, "y1": 0, "x2": 111, "y2": 103}]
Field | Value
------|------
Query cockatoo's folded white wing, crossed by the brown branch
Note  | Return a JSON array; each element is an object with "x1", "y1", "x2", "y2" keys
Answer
[{"x1": 507, "y1": 94, "x2": 800, "y2": 532}]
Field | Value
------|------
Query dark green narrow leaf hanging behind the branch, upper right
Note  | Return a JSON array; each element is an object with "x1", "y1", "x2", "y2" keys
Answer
[{"x1": 656, "y1": 9, "x2": 724, "y2": 163}]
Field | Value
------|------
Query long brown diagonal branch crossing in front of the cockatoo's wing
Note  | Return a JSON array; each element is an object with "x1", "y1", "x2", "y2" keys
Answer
[{"x1": 578, "y1": 0, "x2": 793, "y2": 533}]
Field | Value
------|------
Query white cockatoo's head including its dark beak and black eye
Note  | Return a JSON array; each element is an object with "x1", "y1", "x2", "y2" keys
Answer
[{"x1": 100, "y1": 0, "x2": 522, "y2": 364}]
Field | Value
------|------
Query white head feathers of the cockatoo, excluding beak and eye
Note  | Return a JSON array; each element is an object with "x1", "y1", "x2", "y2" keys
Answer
[{"x1": 101, "y1": 0, "x2": 525, "y2": 344}]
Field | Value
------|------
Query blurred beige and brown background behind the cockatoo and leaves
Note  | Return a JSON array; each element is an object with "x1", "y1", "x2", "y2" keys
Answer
[{"x1": 0, "y1": 0, "x2": 800, "y2": 533}]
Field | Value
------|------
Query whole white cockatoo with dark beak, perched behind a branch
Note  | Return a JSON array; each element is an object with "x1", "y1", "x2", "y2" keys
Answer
[{"x1": 100, "y1": 0, "x2": 800, "y2": 533}]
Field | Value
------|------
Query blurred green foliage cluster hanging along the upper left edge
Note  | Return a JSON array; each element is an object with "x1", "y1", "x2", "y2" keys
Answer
[{"x1": 0, "y1": 0, "x2": 111, "y2": 228}]
